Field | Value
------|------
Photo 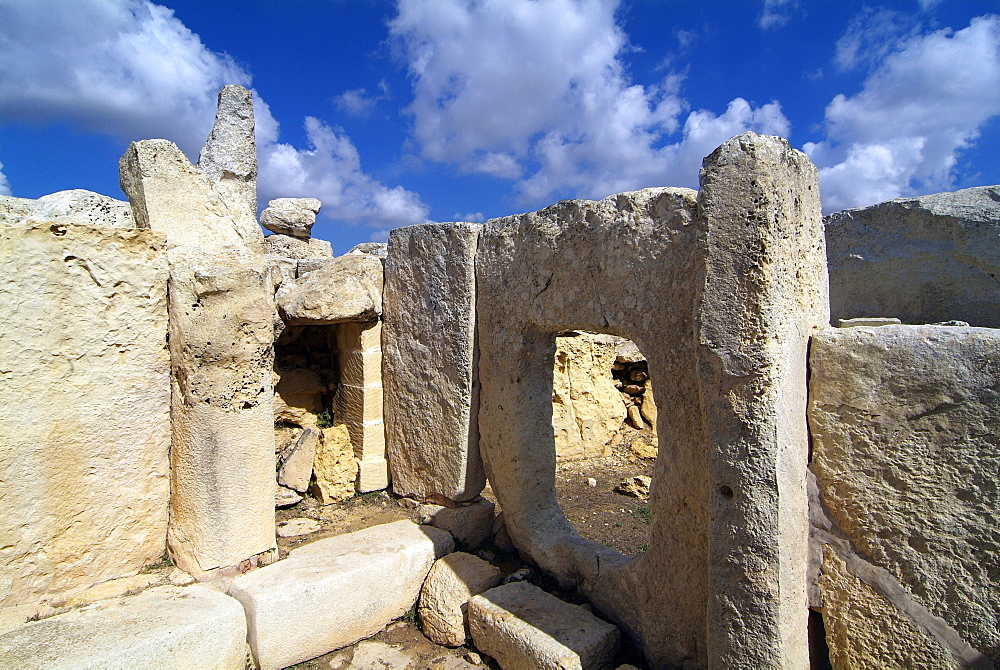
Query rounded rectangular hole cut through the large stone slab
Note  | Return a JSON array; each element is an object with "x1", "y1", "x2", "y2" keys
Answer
[{"x1": 552, "y1": 330, "x2": 657, "y2": 556}]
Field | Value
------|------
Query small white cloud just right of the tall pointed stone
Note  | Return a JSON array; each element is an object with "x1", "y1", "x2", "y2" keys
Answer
[{"x1": 259, "y1": 117, "x2": 428, "y2": 234}]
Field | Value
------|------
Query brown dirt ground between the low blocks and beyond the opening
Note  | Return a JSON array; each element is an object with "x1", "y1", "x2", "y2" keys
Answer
[{"x1": 277, "y1": 428, "x2": 655, "y2": 670}]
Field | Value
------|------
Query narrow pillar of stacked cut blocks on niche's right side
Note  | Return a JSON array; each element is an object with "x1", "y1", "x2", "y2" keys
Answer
[{"x1": 335, "y1": 321, "x2": 389, "y2": 493}]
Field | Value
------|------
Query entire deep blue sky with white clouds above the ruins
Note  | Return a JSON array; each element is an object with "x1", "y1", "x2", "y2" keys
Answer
[{"x1": 0, "y1": 0, "x2": 1000, "y2": 253}]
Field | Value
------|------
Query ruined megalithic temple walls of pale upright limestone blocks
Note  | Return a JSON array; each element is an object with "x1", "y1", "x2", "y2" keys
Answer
[{"x1": 0, "y1": 87, "x2": 1000, "y2": 668}]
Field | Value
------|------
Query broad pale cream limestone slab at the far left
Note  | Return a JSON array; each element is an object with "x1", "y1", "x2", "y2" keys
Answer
[{"x1": 0, "y1": 224, "x2": 170, "y2": 608}]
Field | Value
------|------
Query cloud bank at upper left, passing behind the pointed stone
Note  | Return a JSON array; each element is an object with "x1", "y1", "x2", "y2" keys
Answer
[{"x1": 0, "y1": 0, "x2": 426, "y2": 234}]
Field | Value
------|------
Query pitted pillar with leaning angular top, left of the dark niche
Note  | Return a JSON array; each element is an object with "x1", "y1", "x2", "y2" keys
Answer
[{"x1": 120, "y1": 134, "x2": 276, "y2": 576}]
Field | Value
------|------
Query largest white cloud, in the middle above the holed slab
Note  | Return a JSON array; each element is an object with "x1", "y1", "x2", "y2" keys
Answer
[{"x1": 389, "y1": 0, "x2": 788, "y2": 204}]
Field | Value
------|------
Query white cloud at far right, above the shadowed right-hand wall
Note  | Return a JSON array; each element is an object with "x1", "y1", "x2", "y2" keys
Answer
[{"x1": 804, "y1": 16, "x2": 1000, "y2": 211}]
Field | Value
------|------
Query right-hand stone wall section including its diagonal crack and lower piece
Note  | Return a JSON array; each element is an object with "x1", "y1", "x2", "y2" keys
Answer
[{"x1": 809, "y1": 326, "x2": 1000, "y2": 667}]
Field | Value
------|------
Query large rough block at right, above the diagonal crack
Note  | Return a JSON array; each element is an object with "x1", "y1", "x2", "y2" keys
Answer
[{"x1": 809, "y1": 326, "x2": 1000, "y2": 660}]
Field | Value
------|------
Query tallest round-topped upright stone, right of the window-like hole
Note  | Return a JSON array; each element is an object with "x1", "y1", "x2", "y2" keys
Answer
[{"x1": 696, "y1": 133, "x2": 830, "y2": 668}]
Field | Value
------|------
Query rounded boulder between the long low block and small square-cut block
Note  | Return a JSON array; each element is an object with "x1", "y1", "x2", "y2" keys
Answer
[{"x1": 417, "y1": 552, "x2": 501, "y2": 647}]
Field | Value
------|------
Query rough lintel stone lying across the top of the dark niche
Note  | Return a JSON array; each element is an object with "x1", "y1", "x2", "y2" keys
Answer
[{"x1": 275, "y1": 255, "x2": 382, "y2": 325}]
